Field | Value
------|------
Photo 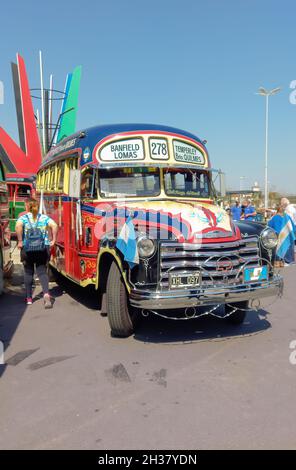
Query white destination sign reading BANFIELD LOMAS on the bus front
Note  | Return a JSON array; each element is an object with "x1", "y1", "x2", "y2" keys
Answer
[{"x1": 100, "y1": 139, "x2": 144, "y2": 162}]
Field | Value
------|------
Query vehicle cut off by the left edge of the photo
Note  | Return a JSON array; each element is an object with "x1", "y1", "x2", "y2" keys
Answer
[{"x1": 0, "y1": 161, "x2": 12, "y2": 295}]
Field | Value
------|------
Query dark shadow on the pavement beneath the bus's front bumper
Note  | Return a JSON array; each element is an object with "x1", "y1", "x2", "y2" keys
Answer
[{"x1": 134, "y1": 308, "x2": 271, "y2": 343}]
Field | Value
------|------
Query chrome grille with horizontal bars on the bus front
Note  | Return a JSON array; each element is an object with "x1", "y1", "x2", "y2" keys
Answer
[{"x1": 159, "y1": 237, "x2": 259, "y2": 289}]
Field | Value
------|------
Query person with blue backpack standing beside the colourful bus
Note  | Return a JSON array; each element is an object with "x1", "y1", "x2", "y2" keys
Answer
[{"x1": 16, "y1": 199, "x2": 58, "y2": 308}]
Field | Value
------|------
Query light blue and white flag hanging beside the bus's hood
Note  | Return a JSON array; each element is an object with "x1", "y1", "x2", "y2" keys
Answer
[{"x1": 116, "y1": 217, "x2": 139, "y2": 268}]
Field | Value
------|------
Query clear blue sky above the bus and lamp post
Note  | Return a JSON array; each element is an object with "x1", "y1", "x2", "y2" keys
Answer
[{"x1": 0, "y1": 0, "x2": 296, "y2": 193}]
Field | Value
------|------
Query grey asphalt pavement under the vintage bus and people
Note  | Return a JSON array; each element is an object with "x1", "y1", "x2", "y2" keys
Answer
[{"x1": 0, "y1": 266, "x2": 296, "y2": 450}]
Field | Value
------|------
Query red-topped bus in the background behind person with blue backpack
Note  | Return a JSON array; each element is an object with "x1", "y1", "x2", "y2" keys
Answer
[{"x1": 6, "y1": 173, "x2": 36, "y2": 235}]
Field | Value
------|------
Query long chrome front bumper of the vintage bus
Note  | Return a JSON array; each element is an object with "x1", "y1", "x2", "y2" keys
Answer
[{"x1": 129, "y1": 275, "x2": 283, "y2": 310}]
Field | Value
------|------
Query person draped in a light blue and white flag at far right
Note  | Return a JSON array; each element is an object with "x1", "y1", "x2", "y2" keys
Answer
[{"x1": 268, "y1": 204, "x2": 295, "y2": 267}]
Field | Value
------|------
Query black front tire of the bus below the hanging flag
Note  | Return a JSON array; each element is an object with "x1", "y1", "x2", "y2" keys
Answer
[{"x1": 106, "y1": 261, "x2": 138, "y2": 338}]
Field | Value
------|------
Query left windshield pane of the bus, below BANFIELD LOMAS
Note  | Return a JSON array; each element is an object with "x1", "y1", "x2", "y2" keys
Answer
[{"x1": 99, "y1": 167, "x2": 160, "y2": 197}]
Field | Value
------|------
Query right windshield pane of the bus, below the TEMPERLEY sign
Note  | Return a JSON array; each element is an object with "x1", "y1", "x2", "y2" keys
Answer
[{"x1": 164, "y1": 168, "x2": 210, "y2": 197}]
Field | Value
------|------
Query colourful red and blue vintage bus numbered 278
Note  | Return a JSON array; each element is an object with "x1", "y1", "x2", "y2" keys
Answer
[{"x1": 37, "y1": 124, "x2": 282, "y2": 336}]
